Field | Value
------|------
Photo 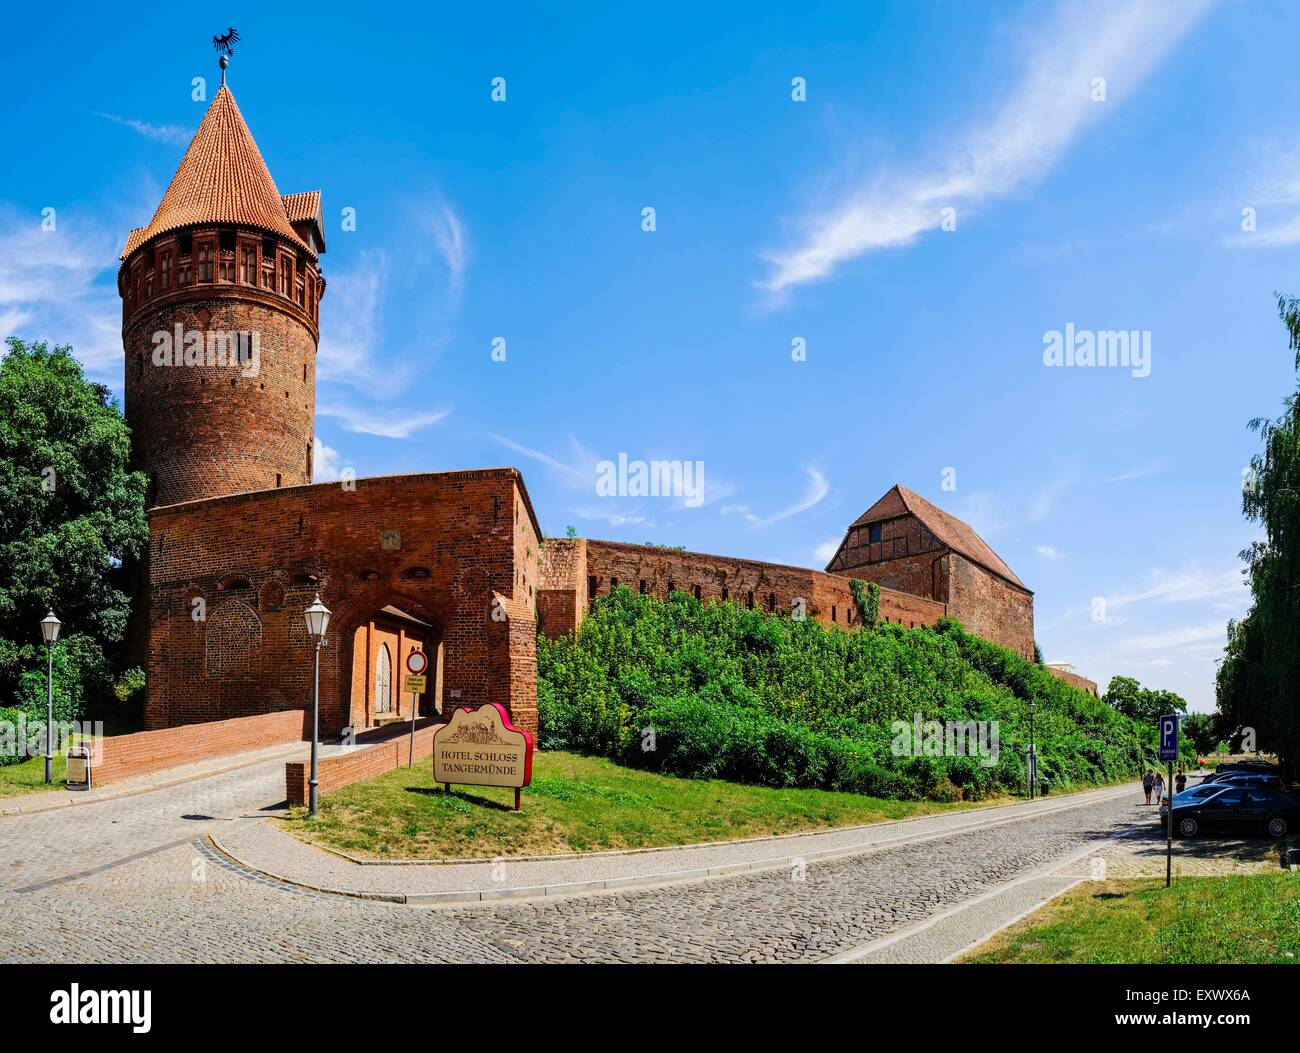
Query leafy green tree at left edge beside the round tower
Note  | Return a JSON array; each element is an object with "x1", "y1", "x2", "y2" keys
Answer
[{"x1": 0, "y1": 338, "x2": 148, "y2": 733}]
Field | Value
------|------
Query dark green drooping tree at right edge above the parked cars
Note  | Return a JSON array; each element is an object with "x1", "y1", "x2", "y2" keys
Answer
[{"x1": 1216, "y1": 295, "x2": 1300, "y2": 776}]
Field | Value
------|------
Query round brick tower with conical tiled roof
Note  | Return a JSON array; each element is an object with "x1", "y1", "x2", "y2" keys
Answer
[{"x1": 117, "y1": 73, "x2": 325, "y2": 506}]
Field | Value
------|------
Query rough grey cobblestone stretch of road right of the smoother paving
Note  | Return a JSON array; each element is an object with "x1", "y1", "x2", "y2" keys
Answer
[{"x1": 451, "y1": 797, "x2": 1135, "y2": 962}]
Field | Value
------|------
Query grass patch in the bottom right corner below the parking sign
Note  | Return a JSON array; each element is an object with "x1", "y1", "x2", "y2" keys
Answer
[{"x1": 962, "y1": 872, "x2": 1300, "y2": 965}]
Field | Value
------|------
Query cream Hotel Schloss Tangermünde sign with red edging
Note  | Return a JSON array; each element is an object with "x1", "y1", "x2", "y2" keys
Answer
[{"x1": 433, "y1": 702, "x2": 533, "y2": 809}]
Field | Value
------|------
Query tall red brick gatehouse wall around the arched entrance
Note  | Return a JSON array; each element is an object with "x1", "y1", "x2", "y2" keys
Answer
[{"x1": 146, "y1": 468, "x2": 540, "y2": 732}]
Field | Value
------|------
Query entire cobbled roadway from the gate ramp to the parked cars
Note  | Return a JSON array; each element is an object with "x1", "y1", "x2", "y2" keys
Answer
[{"x1": 0, "y1": 761, "x2": 1140, "y2": 962}]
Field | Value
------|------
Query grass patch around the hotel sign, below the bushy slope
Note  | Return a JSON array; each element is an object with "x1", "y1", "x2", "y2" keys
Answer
[{"x1": 280, "y1": 750, "x2": 998, "y2": 859}]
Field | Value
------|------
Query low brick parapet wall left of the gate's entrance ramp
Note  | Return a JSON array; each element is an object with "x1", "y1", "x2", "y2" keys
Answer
[{"x1": 91, "y1": 711, "x2": 307, "y2": 785}]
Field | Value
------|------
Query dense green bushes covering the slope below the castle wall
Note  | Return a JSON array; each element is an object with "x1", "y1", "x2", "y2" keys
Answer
[{"x1": 538, "y1": 588, "x2": 1154, "y2": 801}]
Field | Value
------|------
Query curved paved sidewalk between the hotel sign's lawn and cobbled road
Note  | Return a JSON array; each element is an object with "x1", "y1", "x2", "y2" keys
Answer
[{"x1": 211, "y1": 785, "x2": 1134, "y2": 905}]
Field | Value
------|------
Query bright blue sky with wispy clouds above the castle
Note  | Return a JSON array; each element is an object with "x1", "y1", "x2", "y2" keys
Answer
[{"x1": 0, "y1": 0, "x2": 1300, "y2": 709}]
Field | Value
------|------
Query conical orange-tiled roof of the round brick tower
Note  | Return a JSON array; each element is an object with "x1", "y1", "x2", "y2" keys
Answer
[{"x1": 122, "y1": 85, "x2": 320, "y2": 259}]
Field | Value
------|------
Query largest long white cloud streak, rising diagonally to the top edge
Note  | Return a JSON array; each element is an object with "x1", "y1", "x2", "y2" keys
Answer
[{"x1": 761, "y1": 0, "x2": 1212, "y2": 294}]
